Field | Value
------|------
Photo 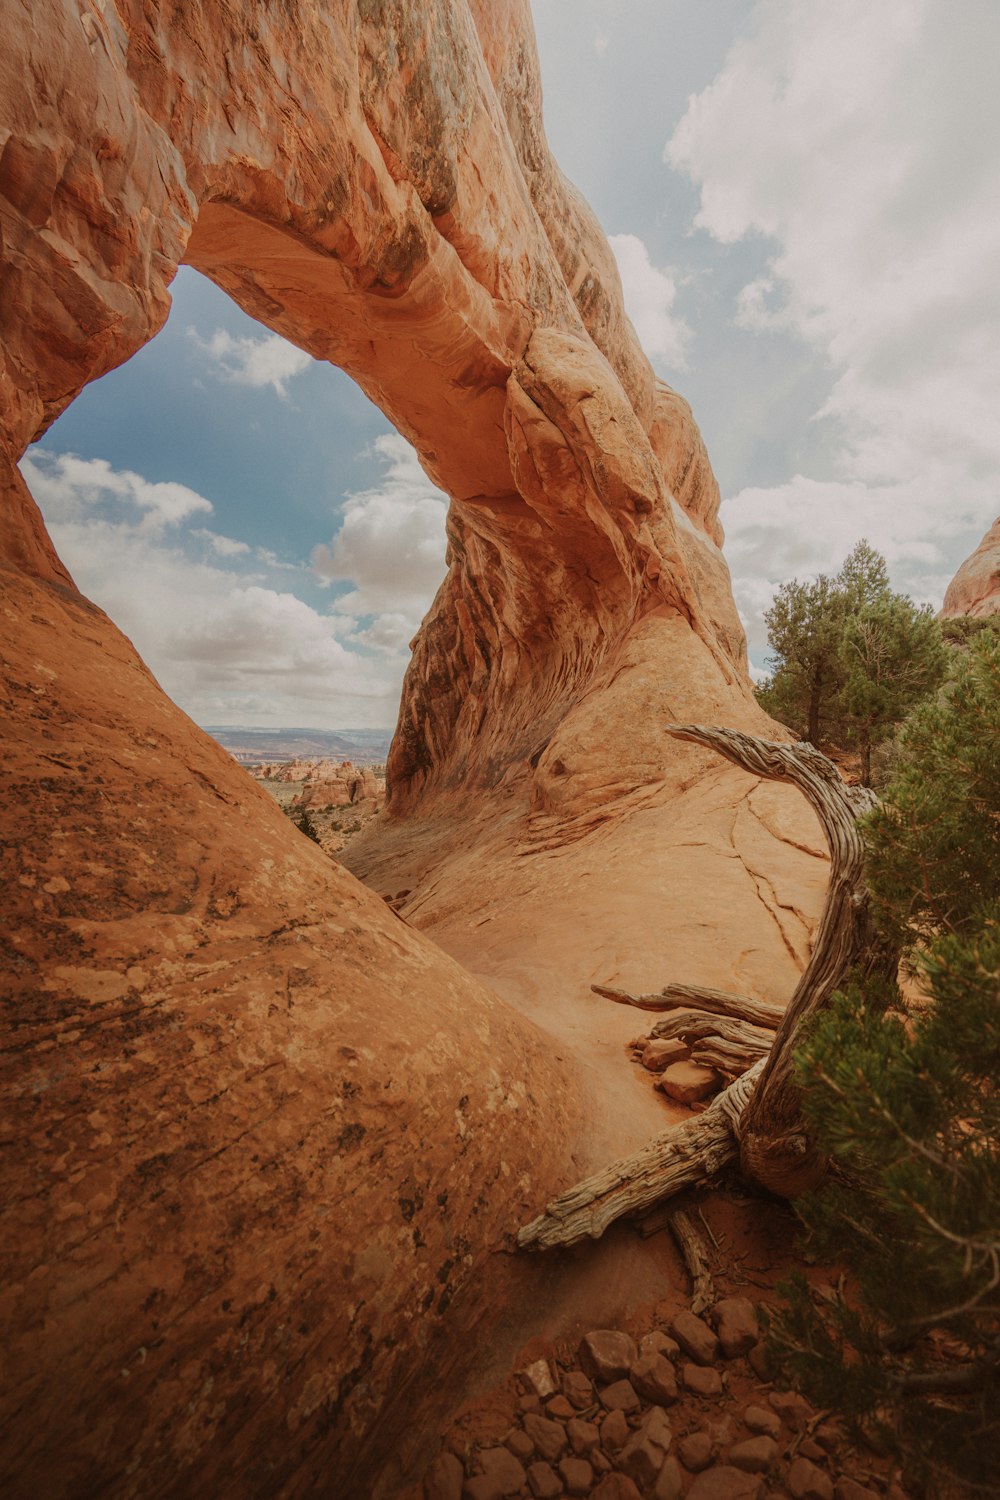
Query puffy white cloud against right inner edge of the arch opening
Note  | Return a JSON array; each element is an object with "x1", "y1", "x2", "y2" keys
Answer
[{"x1": 312, "y1": 435, "x2": 448, "y2": 650}]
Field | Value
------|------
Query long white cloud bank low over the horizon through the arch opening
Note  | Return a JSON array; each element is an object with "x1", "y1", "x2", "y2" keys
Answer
[{"x1": 22, "y1": 449, "x2": 405, "y2": 728}]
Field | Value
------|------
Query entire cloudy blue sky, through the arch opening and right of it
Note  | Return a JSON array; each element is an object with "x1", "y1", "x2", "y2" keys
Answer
[{"x1": 22, "y1": 0, "x2": 1000, "y2": 729}]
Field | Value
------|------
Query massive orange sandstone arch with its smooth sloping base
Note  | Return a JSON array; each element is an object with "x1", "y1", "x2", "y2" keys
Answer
[{"x1": 0, "y1": 0, "x2": 823, "y2": 1497}]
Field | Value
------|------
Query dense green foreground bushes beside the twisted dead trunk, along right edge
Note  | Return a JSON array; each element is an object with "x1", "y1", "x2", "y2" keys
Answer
[{"x1": 771, "y1": 636, "x2": 1000, "y2": 1496}]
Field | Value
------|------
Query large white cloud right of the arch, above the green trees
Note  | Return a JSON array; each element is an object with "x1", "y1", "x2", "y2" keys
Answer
[{"x1": 666, "y1": 0, "x2": 1000, "y2": 654}]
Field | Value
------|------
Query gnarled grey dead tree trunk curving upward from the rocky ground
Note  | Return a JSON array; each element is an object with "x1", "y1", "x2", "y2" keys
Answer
[{"x1": 517, "y1": 725, "x2": 897, "y2": 1250}]
